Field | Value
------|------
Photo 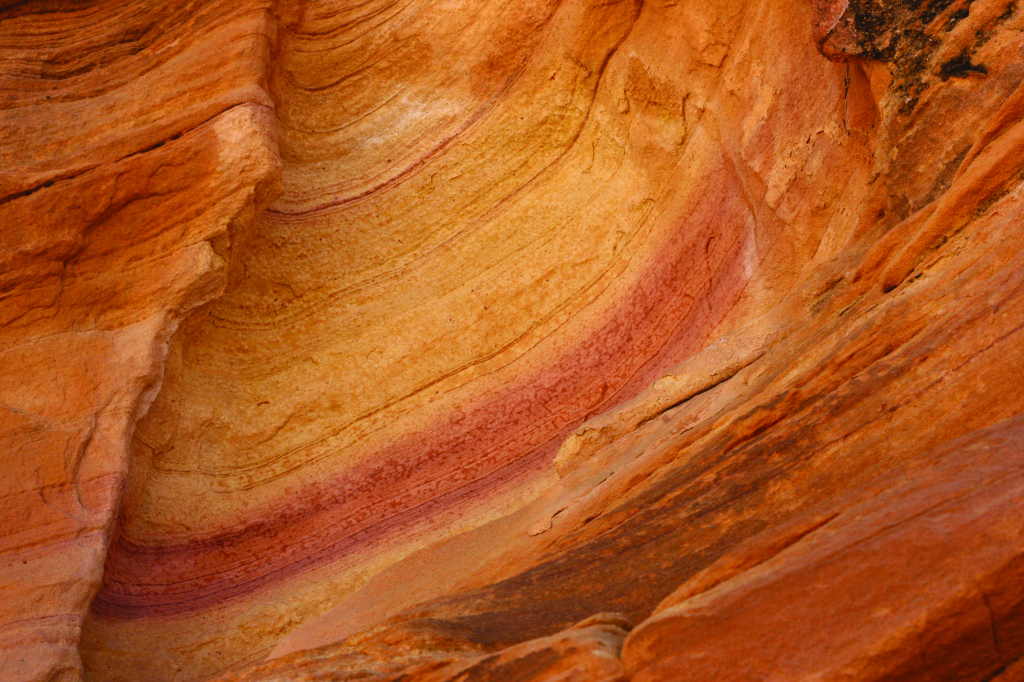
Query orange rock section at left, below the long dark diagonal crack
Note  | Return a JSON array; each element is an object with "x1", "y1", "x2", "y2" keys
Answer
[{"x1": 0, "y1": 105, "x2": 278, "y2": 680}]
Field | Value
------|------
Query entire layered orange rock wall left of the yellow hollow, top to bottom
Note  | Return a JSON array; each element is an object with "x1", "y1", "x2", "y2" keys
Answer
[{"x1": 0, "y1": 2, "x2": 280, "y2": 680}]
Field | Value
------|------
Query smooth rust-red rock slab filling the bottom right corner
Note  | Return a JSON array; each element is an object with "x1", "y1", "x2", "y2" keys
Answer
[{"x1": 624, "y1": 418, "x2": 1024, "y2": 682}]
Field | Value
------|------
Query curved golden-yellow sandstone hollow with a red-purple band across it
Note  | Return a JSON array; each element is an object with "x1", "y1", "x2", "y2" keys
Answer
[{"x1": 83, "y1": 0, "x2": 868, "y2": 679}]
